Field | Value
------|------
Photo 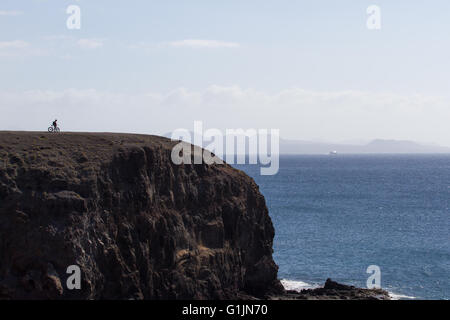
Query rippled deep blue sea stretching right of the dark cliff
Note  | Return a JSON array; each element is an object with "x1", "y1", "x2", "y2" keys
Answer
[{"x1": 235, "y1": 155, "x2": 450, "y2": 299}]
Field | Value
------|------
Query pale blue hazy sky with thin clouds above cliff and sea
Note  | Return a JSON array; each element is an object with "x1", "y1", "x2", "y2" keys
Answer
[{"x1": 0, "y1": 0, "x2": 450, "y2": 145}]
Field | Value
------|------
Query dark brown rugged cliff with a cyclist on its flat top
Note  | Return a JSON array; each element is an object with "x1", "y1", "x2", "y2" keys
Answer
[{"x1": 0, "y1": 132, "x2": 282, "y2": 299}]
